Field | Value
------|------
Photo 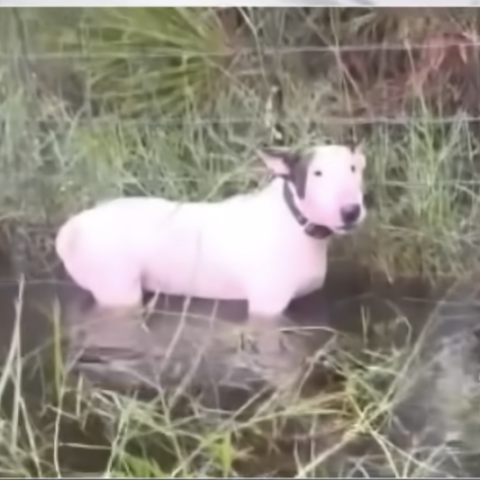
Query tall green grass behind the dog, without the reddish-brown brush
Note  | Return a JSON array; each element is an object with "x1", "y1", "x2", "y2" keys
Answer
[{"x1": 0, "y1": 9, "x2": 478, "y2": 278}]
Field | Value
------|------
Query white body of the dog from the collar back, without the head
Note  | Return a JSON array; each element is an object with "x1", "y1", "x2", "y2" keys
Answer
[{"x1": 54, "y1": 179, "x2": 329, "y2": 314}]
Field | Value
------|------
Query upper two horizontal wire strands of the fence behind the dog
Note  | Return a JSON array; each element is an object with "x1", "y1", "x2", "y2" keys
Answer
[{"x1": 4, "y1": 40, "x2": 480, "y2": 128}]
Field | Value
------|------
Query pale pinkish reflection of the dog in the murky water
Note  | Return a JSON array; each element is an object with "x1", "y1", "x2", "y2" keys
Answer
[{"x1": 64, "y1": 286, "x2": 338, "y2": 404}]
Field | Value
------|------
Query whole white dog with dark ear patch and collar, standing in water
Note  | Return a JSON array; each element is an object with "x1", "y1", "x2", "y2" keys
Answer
[{"x1": 56, "y1": 145, "x2": 366, "y2": 374}]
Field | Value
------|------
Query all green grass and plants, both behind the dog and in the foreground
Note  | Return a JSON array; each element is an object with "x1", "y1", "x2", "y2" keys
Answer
[{"x1": 0, "y1": 8, "x2": 480, "y2": 477}]
